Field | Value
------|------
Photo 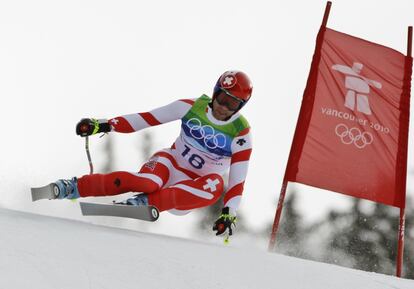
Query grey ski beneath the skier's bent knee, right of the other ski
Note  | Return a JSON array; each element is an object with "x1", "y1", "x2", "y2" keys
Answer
[{"x1": 80, "y1": 202, "x2": 160, "y2": 222}]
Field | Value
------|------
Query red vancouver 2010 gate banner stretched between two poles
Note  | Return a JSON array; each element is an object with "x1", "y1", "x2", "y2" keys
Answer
[{"x1": 287, "y1": 28, "x2": 412, "y2": 208}]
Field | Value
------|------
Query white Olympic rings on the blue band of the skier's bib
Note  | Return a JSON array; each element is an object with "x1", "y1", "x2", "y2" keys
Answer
[{"x1": 186, "y1": 117, "x2": 226, "y2": 149}]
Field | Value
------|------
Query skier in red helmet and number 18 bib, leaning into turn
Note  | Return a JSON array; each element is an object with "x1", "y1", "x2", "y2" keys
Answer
[{"x1": 55, "y1": 71, "x2": 252, "y2": 235}]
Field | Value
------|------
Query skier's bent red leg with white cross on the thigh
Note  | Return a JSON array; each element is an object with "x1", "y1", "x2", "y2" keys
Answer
[{"x1": 148, "y1": 174, "x2": 224, "y2": 212}]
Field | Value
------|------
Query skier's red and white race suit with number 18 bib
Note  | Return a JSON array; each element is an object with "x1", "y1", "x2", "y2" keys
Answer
[{"x1": 78, "y1": 95, "x2": 252, "y2": 214}]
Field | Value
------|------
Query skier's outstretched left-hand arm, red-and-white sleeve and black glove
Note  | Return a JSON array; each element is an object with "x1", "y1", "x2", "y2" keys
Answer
[{"x1": 76, "y1": 99, "x2": 194, "y2": 136}]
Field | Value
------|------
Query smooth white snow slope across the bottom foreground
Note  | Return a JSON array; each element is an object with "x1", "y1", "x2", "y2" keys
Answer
[{"x1": 0, "y1": 209, "x2": 414, "y2": 289}]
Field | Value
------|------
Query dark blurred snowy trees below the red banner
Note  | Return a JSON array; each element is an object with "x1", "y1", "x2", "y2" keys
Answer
[{"x1": 263, "y1": 191, "x2": 414, "y2": 279}]
